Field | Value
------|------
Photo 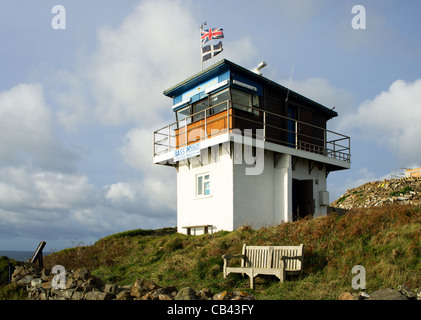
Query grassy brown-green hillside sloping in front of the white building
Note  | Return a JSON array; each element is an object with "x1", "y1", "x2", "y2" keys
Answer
[{"x1": 44, "y1": 205, "x2": 421, "y2": 299}]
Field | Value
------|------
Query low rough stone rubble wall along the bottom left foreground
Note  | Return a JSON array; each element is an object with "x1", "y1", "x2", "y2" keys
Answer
[{"x1": 12, "y1": 263, "x2": 254, "y2": 300}]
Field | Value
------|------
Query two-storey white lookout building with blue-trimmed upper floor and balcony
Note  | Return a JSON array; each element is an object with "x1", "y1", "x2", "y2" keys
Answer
[{"x1": 153, "y1": 60, "x2": 350, "y2": 234}]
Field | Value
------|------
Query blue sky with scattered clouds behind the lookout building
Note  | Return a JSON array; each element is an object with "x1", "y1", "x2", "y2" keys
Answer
[{"x1": 0, "y1": 0, "x2": 421, "y2": 252}]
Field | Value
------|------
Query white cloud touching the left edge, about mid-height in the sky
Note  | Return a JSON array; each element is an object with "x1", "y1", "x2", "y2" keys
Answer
[{"x1": 0, "y1": 83, "x2": 76, "y2": 170}]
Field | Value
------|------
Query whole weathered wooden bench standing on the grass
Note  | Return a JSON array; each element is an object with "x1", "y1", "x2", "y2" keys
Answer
[{"x1": 222, "y1": 244, "x2": 304, "y2": 289}]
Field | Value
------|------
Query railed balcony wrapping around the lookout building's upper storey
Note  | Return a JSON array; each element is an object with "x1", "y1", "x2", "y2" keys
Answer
[{"x1": 153, "y1": 100, "x2": 351, "y2": 163}]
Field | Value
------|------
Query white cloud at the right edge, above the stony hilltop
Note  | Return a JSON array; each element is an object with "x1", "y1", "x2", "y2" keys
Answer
[{"x1": 340, "y1": 79, "x2": 421, "y2": 165}]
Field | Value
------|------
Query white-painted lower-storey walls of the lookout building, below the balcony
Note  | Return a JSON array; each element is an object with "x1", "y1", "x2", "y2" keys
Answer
[{"x1": 177, "y1": 142, "x2": 327, "y2": 234}]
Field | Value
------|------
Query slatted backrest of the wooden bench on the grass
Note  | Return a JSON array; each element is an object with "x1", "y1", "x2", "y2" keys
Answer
[{"x1": 242, "y1": 244, "x2": 304, "y2": 271}]
